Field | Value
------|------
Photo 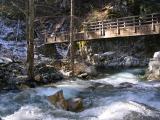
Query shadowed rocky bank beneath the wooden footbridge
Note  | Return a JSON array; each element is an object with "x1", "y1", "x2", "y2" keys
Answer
[{"x1": 72, "y1": 35, "x2": 160, "y2": 69}]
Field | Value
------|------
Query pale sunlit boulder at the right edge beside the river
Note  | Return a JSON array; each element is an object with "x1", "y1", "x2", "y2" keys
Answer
[{"x1": 147, "y1": 51, "x2": 160, "y2": 80}]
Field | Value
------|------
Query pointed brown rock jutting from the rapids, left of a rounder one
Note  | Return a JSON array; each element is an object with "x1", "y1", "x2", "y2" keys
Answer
[{"x1": 48, "y1": 90, "x2": 68, "y2": 110}]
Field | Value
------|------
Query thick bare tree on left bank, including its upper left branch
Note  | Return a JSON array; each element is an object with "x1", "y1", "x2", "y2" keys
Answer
[{"x1": 8, "y1": 0, "x2": 35, "y2": 80}]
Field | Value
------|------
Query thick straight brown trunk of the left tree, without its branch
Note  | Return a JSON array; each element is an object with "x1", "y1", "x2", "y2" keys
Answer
[{"x1": 27, "y1": 0, "x2": 34, "y2": 80}]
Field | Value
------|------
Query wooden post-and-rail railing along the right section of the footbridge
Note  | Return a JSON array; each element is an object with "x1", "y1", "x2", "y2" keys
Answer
[{"x1": 83, "y1": 13, "x2": 160, "y2": 31}]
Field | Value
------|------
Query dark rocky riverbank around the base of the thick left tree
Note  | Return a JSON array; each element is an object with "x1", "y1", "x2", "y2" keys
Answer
[{"x1": 0, "y1": 57, "x2": 63, "y2": 91}]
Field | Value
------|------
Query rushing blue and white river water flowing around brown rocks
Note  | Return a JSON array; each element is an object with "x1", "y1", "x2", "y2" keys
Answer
[{"x1": 0, "y1": 69, "x2": 160, "y2": 120}]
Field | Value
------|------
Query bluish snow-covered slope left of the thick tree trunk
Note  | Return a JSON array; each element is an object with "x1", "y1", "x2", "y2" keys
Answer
[{"x1": 0, "y1": 19, "x2": 27, "y2": 60}]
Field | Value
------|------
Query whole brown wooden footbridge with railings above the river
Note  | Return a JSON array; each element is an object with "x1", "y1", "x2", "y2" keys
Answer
[{"x1": 45, "y1": 13, "x2": 160, "y2": 44}]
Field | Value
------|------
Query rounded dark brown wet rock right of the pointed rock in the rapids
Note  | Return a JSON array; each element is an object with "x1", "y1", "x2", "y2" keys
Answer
[{"x1": 68, "y1": 98, "x2": 83, "y2": 112}]
